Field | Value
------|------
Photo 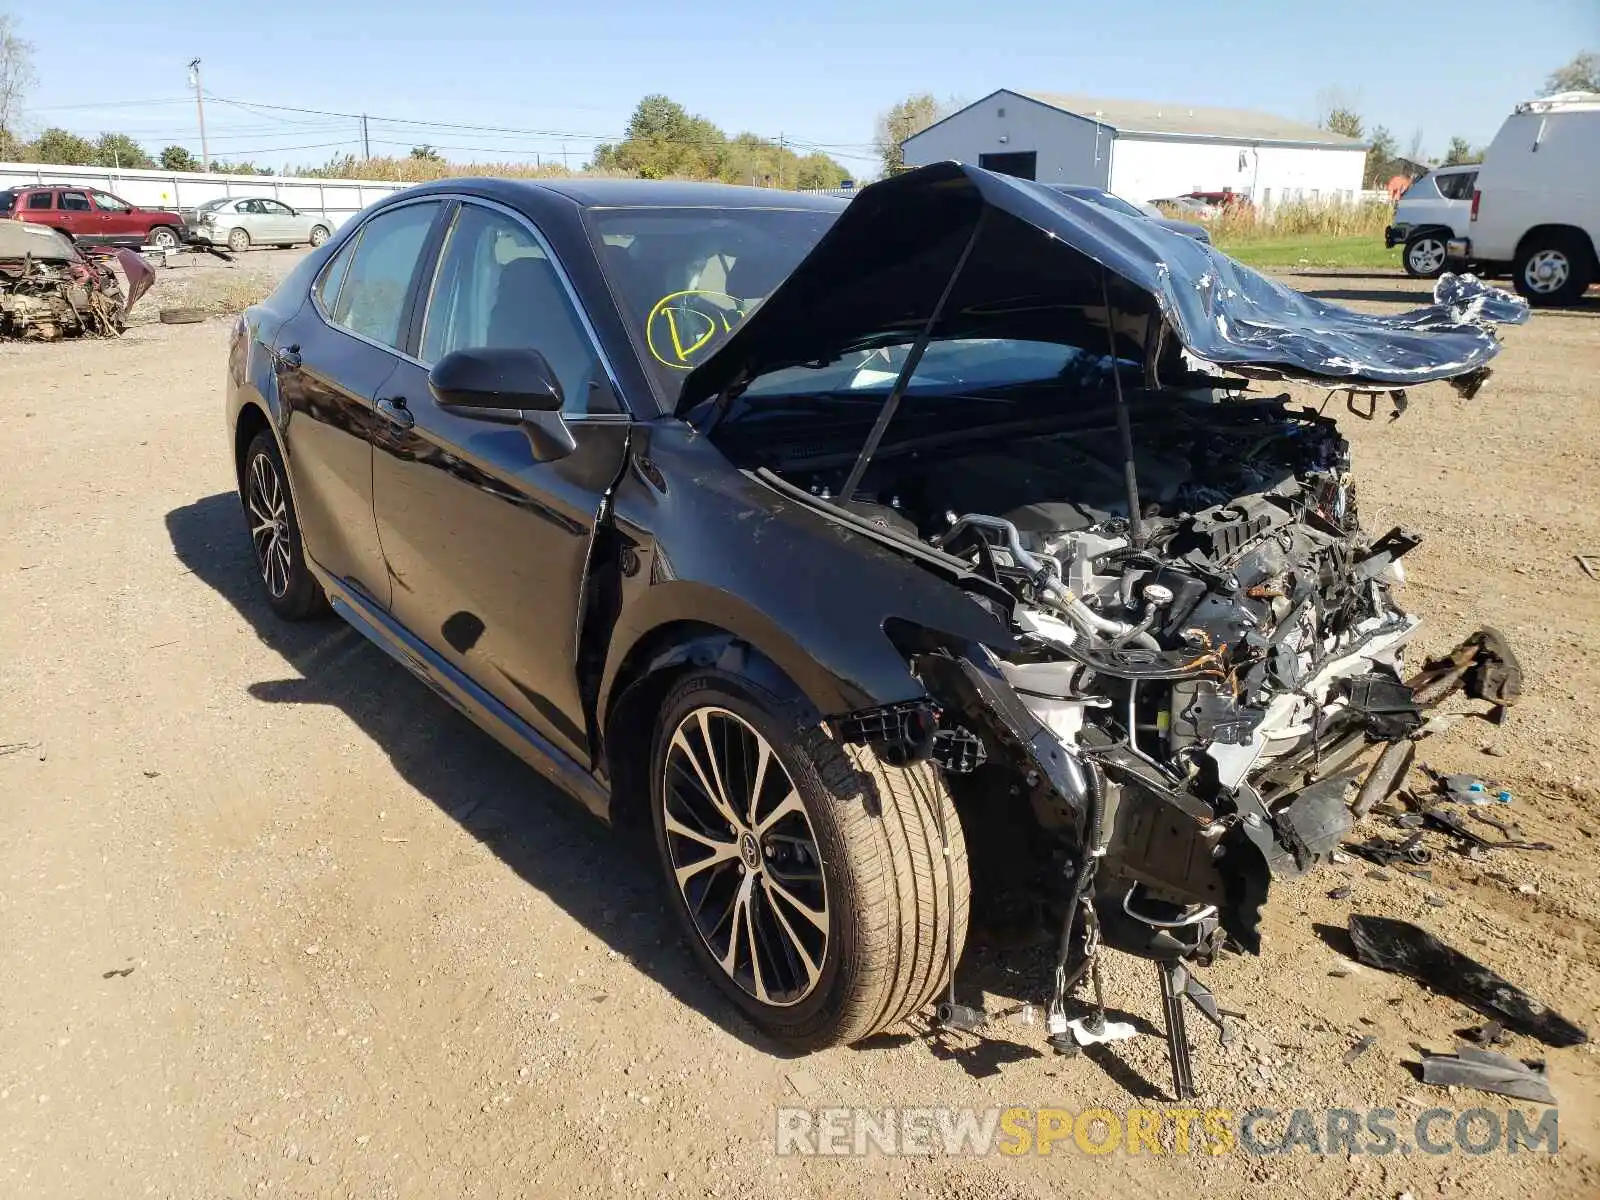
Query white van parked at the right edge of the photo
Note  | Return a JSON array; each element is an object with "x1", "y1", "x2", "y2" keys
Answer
[{"x1": 1450, "y1": 91, "x2": 1600, "y2": 304}]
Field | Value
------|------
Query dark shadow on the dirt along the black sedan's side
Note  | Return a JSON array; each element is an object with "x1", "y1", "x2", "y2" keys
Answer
[{"x1": 166, "y1": 493, "x2": 790, "y2": 1056}]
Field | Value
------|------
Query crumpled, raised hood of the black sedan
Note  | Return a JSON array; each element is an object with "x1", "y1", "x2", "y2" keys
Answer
[{"x1": 677, "y1": 163, "x2": 1528, "y2": 416}]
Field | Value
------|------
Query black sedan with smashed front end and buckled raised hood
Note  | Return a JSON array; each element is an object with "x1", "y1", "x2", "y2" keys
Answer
[{"x1": 227, "y1": 165, "x2": 1525, "y2": 1046}]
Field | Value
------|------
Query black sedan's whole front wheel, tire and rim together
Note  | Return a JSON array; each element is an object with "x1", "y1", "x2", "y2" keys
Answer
[{"x1": 651, "y1": 670, "x2": 971, "y2": 1050}]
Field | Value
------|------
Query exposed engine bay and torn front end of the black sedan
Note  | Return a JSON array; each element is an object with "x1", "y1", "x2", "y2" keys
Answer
[{"x1": 758, "y1": 394, "x2": 1440, "y2": 979}]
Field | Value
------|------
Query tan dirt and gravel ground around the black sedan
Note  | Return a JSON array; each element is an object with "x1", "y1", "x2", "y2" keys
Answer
[{"x1": 0, "y1": 265, "x2": 1600, "y2": 1200}]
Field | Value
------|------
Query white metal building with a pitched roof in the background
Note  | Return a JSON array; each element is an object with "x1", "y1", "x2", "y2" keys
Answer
[{"x1": 902, "y1": 88, "x2": 1366, "y2": 206}]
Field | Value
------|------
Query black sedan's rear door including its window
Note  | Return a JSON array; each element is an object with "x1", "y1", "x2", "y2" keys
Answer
[{"x1": 275, "y1": 200, "x2": 443, "y2": 608}]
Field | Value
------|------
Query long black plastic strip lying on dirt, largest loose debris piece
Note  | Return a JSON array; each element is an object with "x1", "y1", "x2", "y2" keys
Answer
[{"x1": 1349, "y1": 915, "x2": 1589, "y2": 1046}]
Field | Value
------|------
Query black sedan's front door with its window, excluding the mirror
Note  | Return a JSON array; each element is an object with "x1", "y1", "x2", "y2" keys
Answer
[{"x1": 373, "y1": 203, "x2": 629, "y2": 762}]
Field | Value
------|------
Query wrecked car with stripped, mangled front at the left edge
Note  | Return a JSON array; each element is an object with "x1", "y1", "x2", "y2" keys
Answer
[{"x1": 0, "y1": 221, "x2": 155, "y2": 341}]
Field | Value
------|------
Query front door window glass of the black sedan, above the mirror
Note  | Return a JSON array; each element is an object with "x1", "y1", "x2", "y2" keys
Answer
[{"x1": 421, "y1": 205, "x2": 618, "y2": 416}]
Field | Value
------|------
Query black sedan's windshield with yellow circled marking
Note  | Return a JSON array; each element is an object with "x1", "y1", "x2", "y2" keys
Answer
[{"x1": 589, "y1": 208, "x2": 838, "y2": 406}]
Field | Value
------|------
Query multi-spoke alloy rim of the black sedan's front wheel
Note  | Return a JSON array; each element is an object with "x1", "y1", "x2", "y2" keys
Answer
[{"x1": 661, "y1": 707, "x2": 829, "y2": 1008}]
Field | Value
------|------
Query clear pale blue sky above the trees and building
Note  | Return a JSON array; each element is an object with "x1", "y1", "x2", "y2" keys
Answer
[{"x1": 0, "y1": 0, "x2": 1600, "y2": 176}]
